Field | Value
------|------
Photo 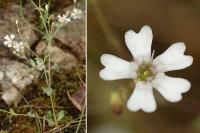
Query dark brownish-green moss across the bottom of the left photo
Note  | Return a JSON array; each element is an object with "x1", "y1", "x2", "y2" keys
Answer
[{"x1": 0, "y1": 65, "x2": 85, "y2": 133}]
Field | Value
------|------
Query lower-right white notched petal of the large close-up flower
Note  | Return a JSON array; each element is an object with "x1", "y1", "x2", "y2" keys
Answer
[{"x1": 152, "y1": 73, "x2": 191, "y2": 102}]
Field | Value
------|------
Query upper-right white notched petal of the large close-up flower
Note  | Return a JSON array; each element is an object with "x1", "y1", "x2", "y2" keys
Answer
[{"x1": 153, "y1": 42, "x2": 193, "y2": 72}]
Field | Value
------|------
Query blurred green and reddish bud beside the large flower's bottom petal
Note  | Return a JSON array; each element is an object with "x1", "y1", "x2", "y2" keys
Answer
[{"x1": 110, "y1": 91, "x2": 123, "y2": 115}]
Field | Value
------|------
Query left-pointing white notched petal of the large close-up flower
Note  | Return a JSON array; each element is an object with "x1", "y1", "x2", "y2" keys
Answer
[{"x1": 99, "y1": 54, "x2": 137, "y2": 80}]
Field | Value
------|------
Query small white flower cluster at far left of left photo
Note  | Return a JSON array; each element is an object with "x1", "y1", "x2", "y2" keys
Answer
[{"x1": 3, "y1": 34, "x2": 25, "y2": 55}]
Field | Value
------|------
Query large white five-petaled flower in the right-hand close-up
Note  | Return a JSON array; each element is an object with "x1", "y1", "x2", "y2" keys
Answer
[{"x1": 100, "y1": 26, "x2": 193, "y2": 112}]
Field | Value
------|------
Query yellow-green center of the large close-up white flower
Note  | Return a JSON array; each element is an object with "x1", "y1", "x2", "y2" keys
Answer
[{"x1": 137, "y1": 64, "x2": 153, "y2": 81}]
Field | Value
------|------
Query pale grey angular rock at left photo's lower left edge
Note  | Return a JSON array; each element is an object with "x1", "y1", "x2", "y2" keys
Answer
[{"x1": 0, "y1": 58, "x2": 39, "y2": 105}]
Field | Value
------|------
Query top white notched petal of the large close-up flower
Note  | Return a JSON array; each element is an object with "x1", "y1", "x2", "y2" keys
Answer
[{"x1": 125, "y1": 26, "x2": 153, "y2": 63}]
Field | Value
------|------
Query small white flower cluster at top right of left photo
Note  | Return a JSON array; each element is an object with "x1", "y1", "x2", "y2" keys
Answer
[{"x1": 57, "y1": 8, "x2": 82, "y2": 24}]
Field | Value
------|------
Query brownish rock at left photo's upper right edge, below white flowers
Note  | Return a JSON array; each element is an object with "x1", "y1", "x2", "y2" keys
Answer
[{"x1": 55, "y1": 7, "x2": 86, "y2": 61}]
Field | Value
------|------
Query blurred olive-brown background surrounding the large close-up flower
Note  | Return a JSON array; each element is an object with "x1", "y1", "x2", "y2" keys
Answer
[{"x1": 88, "y1": 0, "x2": 200, "y2": 133}]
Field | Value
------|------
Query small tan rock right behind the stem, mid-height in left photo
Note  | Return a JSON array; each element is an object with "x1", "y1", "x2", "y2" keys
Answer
[{"x1": 48, "y1": 46, "x2": 78, "y2": 71}]
